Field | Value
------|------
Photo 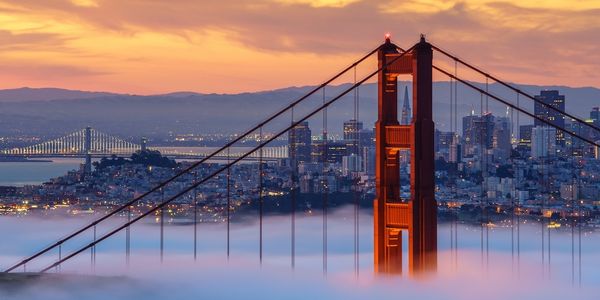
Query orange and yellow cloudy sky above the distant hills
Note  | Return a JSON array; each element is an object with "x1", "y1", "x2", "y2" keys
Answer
[{"x1": 0, "y1": 0, "x2": 600, "y2": 94}]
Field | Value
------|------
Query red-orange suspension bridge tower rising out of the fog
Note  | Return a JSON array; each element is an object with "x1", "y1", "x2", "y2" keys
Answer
[{"x1": 374, "y1": 36, "x2": 437, "y2": 275}]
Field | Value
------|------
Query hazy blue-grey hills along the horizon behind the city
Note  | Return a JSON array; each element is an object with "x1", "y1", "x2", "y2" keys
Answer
[{"x1": 0, "y1": 82, "x2": 600, "y2": 139}]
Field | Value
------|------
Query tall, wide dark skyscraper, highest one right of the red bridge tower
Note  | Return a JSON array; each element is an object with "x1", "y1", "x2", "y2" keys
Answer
[{"x1": 534, "y1": 90, "x2": 565, "y2": 146}]
